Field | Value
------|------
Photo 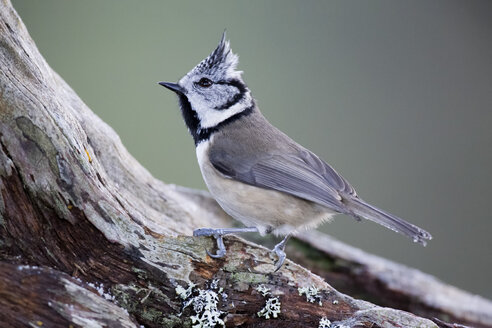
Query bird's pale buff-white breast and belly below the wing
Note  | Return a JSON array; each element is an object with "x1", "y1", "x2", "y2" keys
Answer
[{"x1": 197, "y1": 143, "x2": 334, "y2": 235}]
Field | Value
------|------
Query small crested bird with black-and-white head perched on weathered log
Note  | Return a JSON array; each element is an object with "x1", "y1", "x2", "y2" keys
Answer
[{"x1": 158, "y1": 31, "x2": 432, "y2": 272}]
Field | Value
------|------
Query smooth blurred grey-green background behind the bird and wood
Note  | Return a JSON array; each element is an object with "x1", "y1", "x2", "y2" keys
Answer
[{"x1": 13, "y1": 0, "x2": 492, "y2": 298}]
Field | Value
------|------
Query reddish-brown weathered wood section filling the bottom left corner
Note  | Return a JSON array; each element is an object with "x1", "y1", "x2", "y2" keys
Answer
[{"x1": 0, "y1": 262, "x2": 138, "y2": 327}]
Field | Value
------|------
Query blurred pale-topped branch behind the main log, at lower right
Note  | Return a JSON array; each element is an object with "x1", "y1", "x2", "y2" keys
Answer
[{"x1": 290, "y1": 231, "x2": 492, "y2": 327}]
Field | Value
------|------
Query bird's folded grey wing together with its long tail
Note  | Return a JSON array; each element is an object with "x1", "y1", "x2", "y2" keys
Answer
[{"x1": 210, "y1": 145, "x2": 432, "y2": 245}]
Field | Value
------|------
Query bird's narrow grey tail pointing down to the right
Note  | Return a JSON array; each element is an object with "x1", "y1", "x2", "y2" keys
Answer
[{"x1": 343, "y1": 197, "x2": 432, "y2": 246}]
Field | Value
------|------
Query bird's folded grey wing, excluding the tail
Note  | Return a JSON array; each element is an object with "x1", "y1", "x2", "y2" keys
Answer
[{"x1": 209, "y1": 145, "x2": 355, "y2": 213}]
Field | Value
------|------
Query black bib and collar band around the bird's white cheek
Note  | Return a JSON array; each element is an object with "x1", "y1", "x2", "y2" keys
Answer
[{"x1": 178, "y1": 94, "x2": 255, "y2": 146}]
